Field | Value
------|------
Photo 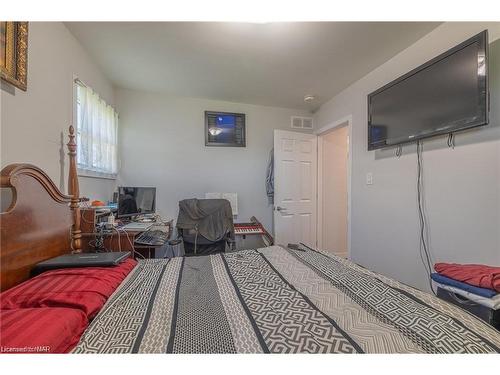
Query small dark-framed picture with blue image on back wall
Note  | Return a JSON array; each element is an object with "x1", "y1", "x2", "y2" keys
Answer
[{"x1": 205, "y1": 111, "x2": 246, "y2": 147}]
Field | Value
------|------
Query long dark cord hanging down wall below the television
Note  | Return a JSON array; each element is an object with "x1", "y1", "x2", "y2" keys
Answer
[{"x1": 417, "y1": 141, "x2": 437, "y2": 296}]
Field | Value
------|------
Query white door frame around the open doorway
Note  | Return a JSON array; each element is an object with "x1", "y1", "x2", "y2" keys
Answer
[{"x1": 314, "y1": 115, "x2": 352, "y2": 259}]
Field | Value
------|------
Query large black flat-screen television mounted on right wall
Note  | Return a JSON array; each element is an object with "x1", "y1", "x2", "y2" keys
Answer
[{"x1": 368, "y1": 30, "x2": 489, "y2": 150}]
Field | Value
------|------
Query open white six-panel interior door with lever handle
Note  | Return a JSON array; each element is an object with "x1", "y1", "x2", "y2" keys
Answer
[{"x1": 274, "y1": 130, "x2": 318, "y2": 247}]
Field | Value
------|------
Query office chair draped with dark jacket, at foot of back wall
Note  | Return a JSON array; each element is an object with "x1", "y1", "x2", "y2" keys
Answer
[{"x1": 176, "y1": 199, "x2": 234, "y2": 256}]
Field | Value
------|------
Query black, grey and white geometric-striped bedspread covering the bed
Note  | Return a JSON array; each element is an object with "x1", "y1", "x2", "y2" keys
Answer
[{"x1": 73, "y1": 246, "x2": 500, "y2": 353}]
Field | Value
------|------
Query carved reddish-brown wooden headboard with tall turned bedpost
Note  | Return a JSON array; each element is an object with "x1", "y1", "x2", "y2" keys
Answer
[{"x1": 0, "y1": 126, "x2": 82, "y2": 291}]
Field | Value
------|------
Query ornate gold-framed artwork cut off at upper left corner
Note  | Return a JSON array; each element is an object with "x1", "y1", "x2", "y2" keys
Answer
[{"x1": 0, "y1": 21, "x2": 28, "y2": 91}]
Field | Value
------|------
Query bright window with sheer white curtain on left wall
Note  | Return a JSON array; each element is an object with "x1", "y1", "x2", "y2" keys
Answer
[{"x1": 75, "y1": 80, "x2": 118, "y2": 178}]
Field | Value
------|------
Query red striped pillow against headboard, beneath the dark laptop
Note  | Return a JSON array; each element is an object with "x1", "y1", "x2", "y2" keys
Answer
[{"x1": 0, "y1": 259, "x2": 137, "y2": 319}]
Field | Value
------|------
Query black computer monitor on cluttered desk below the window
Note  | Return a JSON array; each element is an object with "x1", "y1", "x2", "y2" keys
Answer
[{"x1": 118, "y1": 186, "x2": 156, "y2": 217}]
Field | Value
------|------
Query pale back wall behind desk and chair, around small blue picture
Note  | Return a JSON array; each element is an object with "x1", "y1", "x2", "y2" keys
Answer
[{"x1": 115, "y1": 90, "x2": 307, "y2": 229}]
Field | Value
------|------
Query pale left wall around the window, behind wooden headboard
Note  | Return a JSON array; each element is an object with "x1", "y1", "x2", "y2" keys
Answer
[{"x1": 0, "y1": 22, "x2": 115, "y2": 203}]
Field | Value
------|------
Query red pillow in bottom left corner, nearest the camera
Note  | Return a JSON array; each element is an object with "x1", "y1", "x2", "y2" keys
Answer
[{"x1": 0, "y1": 307, "x2": 88, "y2": 353}]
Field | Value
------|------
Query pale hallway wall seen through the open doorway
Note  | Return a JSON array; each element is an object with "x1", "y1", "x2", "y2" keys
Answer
[{"x1": 320, "y1": 126, "x2": 349, "y2": 257}]
